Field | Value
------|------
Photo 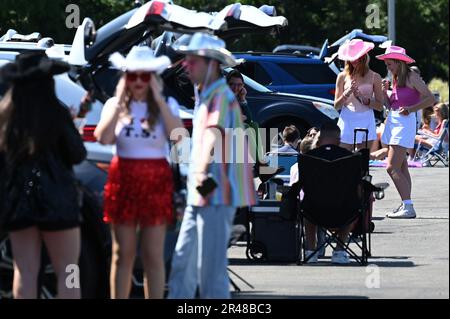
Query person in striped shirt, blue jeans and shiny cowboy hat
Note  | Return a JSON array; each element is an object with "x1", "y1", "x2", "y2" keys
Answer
[{"x1": 169, "y1": 33, "x2": 255, "y2": 299}]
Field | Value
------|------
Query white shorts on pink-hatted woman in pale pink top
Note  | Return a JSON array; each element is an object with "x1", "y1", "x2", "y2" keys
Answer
[{"x1": 337, "y1": 107, "x2": 377, "y2": 144}]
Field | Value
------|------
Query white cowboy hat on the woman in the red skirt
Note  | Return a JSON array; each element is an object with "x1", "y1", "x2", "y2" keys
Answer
[{"x1": 109, "y1": 46, "x2": 171, "y2": 74}]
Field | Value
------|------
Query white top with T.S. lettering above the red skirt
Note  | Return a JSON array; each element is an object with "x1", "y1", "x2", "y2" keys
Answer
[{"x1": 102, "y1": 97, "x2": 180, "y2": 159}]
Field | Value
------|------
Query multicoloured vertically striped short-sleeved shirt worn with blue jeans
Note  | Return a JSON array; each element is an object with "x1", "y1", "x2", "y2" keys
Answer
[{"x1": 188, "y1": 79, "x2": 256, "y2": 207}]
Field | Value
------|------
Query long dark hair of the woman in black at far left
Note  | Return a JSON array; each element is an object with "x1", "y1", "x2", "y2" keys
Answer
[{"x1": 0, "y1": 76, "x2": 70, "y2": 165}]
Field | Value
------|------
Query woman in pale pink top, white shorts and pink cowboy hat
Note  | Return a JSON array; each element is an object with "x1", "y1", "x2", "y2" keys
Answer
[{"x1": 334, "y1": 39, "x2": 383, "y2": 150}]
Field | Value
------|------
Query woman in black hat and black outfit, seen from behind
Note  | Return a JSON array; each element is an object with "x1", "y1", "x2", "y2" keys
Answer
[{"x1": 0, "y1": 52, "x2": 86, "y2": 299}]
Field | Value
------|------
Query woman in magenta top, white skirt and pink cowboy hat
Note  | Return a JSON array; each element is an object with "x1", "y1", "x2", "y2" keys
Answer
[{"x1": 377, "y1": 46, "x2": 434, "y2": 218}]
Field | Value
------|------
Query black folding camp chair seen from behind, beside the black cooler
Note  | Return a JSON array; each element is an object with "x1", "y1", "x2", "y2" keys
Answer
[{"x1": 299, "y1": 152, "x2": 382, "y2": 265}]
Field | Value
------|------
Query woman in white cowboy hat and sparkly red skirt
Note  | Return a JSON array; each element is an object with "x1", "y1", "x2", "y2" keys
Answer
[{"x1": 94, "y1": 47, "x2": 183, "y2": 299}]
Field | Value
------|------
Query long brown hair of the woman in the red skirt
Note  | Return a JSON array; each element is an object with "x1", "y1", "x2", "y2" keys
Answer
[{"x1": 116, "y1": 73, "x2": 162, "y2": 131}]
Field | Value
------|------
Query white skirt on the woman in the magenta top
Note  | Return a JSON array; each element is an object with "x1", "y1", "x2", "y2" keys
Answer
[{"x1": 381, "y1": 111, "x2": 416, "y2": 148}]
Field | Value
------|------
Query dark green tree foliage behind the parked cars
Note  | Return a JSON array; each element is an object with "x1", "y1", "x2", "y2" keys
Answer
[{"x1": 0, "y1": 0, "x2": 449, "y2": 81}]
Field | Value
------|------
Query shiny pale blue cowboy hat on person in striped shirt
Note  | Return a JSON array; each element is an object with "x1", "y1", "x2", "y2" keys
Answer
[{"x1": 174, "y1": 32, "x2": 237, "y2": 67}]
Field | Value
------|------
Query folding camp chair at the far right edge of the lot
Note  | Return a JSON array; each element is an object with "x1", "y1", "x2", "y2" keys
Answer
[{"x1": 414, "y1": 120, "x2": 448, "y2": 167}]
